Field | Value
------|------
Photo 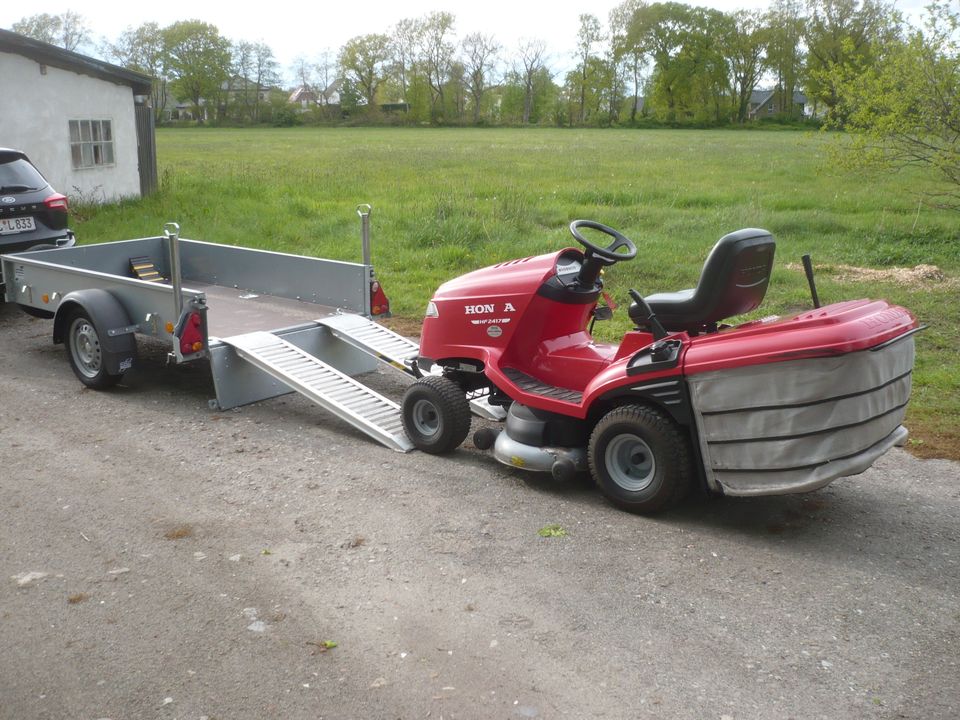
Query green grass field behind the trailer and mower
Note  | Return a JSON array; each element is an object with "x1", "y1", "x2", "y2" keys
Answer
[{"x1": 75, "y1": 128, "x2": 960, "y2": 458}]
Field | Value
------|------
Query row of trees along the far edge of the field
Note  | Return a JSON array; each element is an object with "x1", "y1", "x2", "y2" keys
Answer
[{"x1": 1, "y1": 0, "x2": 903, "y2": 126}]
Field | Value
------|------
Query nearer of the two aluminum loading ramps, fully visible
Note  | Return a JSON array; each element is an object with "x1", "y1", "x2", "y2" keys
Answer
[{"x1": 222, "y1": 330, "x2": 413, "y2": 452}]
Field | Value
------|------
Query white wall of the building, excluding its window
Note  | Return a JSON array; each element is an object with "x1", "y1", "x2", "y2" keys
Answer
[{"x1": 0, "y1": 52, "x2": 140, "y2": 202}]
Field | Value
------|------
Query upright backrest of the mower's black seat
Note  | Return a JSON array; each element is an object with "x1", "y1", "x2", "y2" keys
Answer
[{"x1": 693, "y1": 228, "x2": 776, "y2": 322}]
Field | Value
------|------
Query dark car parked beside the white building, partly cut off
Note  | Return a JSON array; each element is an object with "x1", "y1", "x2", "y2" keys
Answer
[{"x1": 0, "y1": 148, "x2": 76, "y2": 254}]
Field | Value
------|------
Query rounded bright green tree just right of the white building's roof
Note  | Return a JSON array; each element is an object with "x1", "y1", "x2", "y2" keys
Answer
[{"x1": 163, "y1": 20, "x2": 230, "y2": 119}]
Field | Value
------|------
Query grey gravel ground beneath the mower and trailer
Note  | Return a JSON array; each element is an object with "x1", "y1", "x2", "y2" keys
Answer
[{"x1": 0, "y1": 306, "x2": 960, "y2": 720}]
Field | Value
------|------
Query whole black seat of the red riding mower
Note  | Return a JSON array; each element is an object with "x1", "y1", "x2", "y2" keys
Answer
[{"x1": 629, "y1": 228, "x2": 776, "y2": 333}]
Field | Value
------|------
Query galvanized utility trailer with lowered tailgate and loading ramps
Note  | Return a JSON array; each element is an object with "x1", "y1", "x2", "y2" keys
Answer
[{"x1": 0, "y1": 211, "x2": 418, "y2": 452}]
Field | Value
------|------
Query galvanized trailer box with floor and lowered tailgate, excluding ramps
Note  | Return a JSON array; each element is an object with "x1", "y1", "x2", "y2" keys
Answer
[{"x1": 0, "y1": 236, "x2": 392, "y2": 434}]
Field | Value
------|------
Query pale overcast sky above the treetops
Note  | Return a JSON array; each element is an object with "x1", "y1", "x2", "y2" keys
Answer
[{"x1": 0, "y1": 0, "x2": 927, "y2": 83}]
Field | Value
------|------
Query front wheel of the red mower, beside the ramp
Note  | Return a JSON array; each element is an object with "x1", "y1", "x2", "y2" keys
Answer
[{"x1": 402, "y1": 375, "x2": 470, "y2": 455}]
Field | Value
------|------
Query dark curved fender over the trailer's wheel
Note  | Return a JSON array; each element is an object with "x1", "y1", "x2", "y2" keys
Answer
[{"x1": 53, "y1": 288, "x2": 138, "y2": 375}]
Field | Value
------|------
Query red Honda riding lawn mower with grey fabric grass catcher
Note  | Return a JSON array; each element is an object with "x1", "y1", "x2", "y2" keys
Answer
[{"x1": 402, "y1": 220, "x2": 920, "y2": 513}]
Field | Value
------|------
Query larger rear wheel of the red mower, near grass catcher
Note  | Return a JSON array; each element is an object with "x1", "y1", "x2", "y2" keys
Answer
[{"x1": 587, "y1": 405, "x2": 692, "y2": 513}]
